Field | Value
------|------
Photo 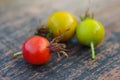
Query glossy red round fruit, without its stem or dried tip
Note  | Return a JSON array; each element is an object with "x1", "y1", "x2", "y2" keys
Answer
[{"x1": 22, "y1": 36, "x2": 51, "y2": 65}]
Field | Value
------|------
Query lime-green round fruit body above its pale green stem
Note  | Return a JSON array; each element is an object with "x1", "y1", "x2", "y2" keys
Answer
[{"x1": 76, "y1": 19, "x2": 105, "y2": 46}]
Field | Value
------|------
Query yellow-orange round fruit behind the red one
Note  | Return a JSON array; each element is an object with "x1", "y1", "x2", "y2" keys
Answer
[{"x1": 47, "y1": 11, "x2": 77, "y2": 41}]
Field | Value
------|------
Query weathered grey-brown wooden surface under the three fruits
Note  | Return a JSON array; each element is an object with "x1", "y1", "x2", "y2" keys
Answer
[{"x1": 0, "y1": 0, "x2": 120, "y2": 80}]
